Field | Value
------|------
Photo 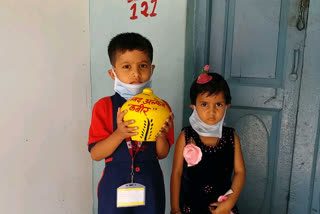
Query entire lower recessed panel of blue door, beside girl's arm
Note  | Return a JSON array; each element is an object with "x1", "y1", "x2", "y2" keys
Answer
[{"x1": 226, "y1": 107, "x2": 280, "y2": 213}]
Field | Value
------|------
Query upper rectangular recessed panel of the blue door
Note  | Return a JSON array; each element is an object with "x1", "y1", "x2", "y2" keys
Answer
[{"x1": 231, "y1": 0, "x2": 281, "y2": 79}]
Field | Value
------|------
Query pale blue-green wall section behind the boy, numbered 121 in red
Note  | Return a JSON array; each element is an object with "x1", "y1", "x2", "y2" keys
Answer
[{"x1": 90, "y1": 0, "x2": 187, "y2": 213}]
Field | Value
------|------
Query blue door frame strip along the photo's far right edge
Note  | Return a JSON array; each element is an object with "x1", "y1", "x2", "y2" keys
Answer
[{"x1": 288, "y1": 0, "x2": 320, "y2": 214}]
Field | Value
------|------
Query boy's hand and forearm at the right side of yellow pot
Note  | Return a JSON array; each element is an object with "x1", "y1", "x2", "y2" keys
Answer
[{"x1": 156, "y1": 112, "x2": 174, "y2": 159}]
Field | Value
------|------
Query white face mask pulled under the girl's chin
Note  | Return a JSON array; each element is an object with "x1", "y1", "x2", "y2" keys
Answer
[{"x1": 189, "y1": 106, "x2": 227, "y2": 138}]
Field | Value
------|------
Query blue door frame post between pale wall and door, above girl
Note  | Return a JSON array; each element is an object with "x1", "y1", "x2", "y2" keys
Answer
[{"x1": 183, "y1": 0, "x2": 212, "y2": 126}]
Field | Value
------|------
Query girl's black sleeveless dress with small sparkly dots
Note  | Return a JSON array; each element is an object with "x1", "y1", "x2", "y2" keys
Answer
[{"x1": 180, "y1": 126, "x2": 239, "y2": 214}]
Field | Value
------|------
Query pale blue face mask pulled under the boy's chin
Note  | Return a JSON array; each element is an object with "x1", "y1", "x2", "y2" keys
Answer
[{"x1": 112, "y1": 69, "x2": 152, "y2": 100}]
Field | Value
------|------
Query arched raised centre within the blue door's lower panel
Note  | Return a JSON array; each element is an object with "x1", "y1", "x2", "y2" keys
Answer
[{"x1": 234, "y1": 113, "x2": 269, "y2": 213}]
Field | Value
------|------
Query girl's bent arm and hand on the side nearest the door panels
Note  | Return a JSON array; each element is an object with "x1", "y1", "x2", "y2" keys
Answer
[{"x1": 211, "y1": 133, "x2": 246, "y2": 214}]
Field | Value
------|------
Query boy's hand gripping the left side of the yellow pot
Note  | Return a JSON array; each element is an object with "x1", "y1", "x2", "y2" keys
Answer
[{"x1": 115, "y1": 108, "x2": 138, "y2": 139}]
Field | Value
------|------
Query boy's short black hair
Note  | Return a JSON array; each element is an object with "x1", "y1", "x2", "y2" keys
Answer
[{"x1": 108, "y1": 33, "x2": 153, "y2": 66}]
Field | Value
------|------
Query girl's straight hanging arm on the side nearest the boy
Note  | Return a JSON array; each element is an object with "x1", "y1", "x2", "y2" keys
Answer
[{"x1": 170, "y1": 131, "x2": 186, "y2": 213}]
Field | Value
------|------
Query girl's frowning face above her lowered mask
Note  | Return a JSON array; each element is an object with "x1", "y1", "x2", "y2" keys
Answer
[{"x1": 191, "y1": 91, "x2": 230, "y2": 125}]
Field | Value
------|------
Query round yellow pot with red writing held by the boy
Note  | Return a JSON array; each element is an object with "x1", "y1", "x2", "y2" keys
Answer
[{"x1": 121, "y1": 88, "x2": 170, "y2": 141}]
